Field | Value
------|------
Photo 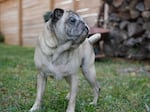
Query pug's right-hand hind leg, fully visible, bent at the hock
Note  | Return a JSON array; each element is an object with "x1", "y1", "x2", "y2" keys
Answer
[{"x1": 82, "y1": 57, "x2": 100, "y2": 105}]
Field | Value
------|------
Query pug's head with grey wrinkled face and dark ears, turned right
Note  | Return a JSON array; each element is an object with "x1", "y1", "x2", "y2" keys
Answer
[{"x1": 45, "y1": 9, "x2": 89, "y2": 44}]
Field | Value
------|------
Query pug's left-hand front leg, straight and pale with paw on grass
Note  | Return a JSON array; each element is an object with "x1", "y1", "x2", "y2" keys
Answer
[{"x1": 30, "y1": 72, "x2": 47, "y2": 112}]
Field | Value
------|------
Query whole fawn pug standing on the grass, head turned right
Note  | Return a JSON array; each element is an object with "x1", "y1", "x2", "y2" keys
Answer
[{"x1": 30, "y1": 8, "x2": 101, "y2": 112}]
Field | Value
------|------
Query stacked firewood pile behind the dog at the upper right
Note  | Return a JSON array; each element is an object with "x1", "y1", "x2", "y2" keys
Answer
[{"x1": 104, "y1": 0, "x2": 150, "y2": 59}]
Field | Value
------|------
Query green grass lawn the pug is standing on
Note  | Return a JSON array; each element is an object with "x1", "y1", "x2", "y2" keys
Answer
[{"x1": 0, "y1": 44, "x2": 150, "y2": 112}]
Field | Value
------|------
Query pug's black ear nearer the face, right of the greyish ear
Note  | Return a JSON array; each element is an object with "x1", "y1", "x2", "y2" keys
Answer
[{"x1": 52, "y1": 8, "x2": 64, "y2": 23}]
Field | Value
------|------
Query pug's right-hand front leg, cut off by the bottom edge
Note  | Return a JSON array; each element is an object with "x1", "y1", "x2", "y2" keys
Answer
[{"x1": 66, "y1": 75, "x2": 78, "y2": 112}]
